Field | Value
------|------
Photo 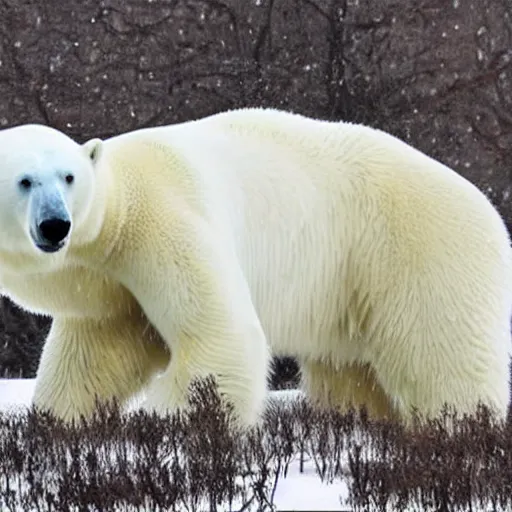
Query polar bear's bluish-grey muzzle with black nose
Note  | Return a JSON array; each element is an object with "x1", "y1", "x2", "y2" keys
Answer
[{"x1": 30, "y1": 187, "x2": 71, "y2": 253}]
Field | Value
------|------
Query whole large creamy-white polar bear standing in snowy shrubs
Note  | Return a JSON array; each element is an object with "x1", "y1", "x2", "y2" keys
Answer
[{"x1": 0, "y1": 108, "x2": 512, "y2": 425}]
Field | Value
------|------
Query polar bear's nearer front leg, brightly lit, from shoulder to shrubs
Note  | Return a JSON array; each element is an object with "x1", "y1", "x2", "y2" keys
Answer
[{"x1": 122, "y1": 215, "x2": 270, "y2": 426}]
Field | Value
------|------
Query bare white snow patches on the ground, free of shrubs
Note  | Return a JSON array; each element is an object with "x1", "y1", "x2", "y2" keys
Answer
[{"x1": 0, "y1": 379, "x2": 351, "y2": 511}]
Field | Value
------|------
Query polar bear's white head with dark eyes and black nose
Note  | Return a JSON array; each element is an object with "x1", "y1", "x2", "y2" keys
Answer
[{"x1": 0, "y1": 124, "x2": 100, "y2": 254}]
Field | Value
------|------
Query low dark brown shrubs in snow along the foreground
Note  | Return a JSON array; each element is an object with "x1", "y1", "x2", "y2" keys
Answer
[{"x1": 0, "y1": 381, "x2": 512, "y2": 512}]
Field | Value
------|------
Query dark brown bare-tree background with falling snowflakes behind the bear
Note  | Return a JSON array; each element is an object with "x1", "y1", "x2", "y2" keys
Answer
[{"x1": 0, "y1": 0, "x2": 512, "y2": 385}]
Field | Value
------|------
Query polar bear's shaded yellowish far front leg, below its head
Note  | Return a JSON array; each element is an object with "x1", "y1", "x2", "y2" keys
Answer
[{"x1": 33, "y1": 314, "x2": 170, "y2": 420}]
